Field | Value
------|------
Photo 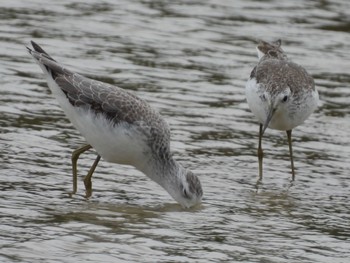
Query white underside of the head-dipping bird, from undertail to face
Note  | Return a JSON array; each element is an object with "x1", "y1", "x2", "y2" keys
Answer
[{"x1": 32, "y1": 54, "x2": 205, "y2": 207}]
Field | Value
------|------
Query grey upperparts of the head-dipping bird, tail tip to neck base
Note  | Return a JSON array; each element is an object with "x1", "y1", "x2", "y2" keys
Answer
[{"x1": 27, "y1": 41, "x2": 170, "y2": 158}]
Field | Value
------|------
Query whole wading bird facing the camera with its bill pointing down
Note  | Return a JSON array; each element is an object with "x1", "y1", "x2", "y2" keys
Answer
[{"x1": 245, "y1": 40, "x2": 319, "y2": 181}]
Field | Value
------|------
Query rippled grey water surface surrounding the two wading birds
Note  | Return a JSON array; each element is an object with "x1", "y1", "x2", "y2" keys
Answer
[{"x1": 0, "y1": 0, "x2": 350, "y2": 263}]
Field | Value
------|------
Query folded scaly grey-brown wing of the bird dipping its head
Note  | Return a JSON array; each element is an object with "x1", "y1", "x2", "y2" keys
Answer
[{"x1": 54, "y1": 73, "x2": 167, "y2": 134}]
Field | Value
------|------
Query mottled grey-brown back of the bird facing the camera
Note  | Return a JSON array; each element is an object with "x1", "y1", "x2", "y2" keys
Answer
[{"x1": 250, "y1": 59, "x2": 315, "y2": 94}]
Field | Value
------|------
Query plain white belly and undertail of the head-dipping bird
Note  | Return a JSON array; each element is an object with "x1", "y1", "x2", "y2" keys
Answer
[{"x1": 50, "y1": 83, "x2": 150, "y2": 169}]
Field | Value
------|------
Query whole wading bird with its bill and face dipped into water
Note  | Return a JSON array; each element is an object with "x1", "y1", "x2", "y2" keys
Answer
[{"x1": 27, "y1": 41, "x2": 203, "y2": 208}]
